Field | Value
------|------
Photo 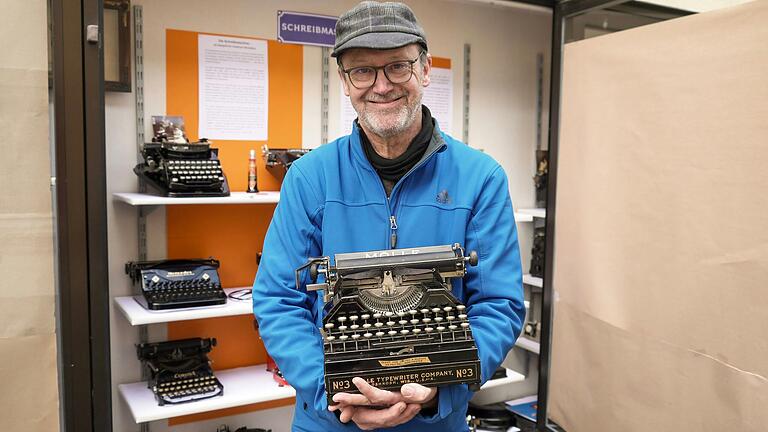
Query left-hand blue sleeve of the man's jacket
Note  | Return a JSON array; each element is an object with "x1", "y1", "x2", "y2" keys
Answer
[{"x1": 253, "y1": 164, "x2": 340, "y2": 424}]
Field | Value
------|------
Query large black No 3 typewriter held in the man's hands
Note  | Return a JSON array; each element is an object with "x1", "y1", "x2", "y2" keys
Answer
[{"x1": 296, "y1": 244, "x2": 480, "y2": 403}]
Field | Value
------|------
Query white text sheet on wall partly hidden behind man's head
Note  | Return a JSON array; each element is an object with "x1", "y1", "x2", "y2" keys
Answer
[{"x1": 339, "y1": 63, "x2": 453, "y2": 136}]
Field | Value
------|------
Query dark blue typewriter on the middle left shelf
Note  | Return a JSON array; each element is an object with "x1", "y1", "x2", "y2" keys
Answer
[{"x1": 125, "y1": 258, "x2": 227, "y2": 311}]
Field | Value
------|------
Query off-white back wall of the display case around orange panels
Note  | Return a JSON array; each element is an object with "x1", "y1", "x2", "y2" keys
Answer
[{"x1": 106, "y1": 0, "x2": 551, "y2": 432}]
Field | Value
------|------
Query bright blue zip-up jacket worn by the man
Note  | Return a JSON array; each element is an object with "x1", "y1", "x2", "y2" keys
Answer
[{"x1": 253, "y1": 123, "x2": 525, "y2": 432}]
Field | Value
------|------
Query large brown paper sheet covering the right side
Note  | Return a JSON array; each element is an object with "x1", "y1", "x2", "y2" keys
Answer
[{"x1": 550, "y1": 1, "x2": 768, "y2": 432}]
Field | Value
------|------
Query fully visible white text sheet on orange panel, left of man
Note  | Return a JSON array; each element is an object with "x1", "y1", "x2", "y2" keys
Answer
[{"x1": 197, "y1": 35, "x2": 269, "y2": 141}]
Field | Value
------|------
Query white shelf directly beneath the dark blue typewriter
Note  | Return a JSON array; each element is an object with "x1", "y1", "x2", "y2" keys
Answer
[{"x1": 115, "y1": 287, "x2": 253, "y2": 326}]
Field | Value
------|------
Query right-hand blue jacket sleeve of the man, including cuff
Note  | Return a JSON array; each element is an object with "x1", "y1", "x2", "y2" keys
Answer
[{"x1": 423, "y1": 166, "x2": 525, "y2": 423}]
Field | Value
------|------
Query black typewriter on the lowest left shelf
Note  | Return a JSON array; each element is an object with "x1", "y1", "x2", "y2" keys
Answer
[{"x1": 136, "y1": 338, "x2": 224, "y2": 405}]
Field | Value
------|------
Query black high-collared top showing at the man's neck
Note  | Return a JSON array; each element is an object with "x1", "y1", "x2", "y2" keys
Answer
[{"x1": 360, "y1": 105, "x2": 435, "y2": 196}]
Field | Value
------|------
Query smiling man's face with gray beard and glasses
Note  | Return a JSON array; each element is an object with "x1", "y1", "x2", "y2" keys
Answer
[{"x1": 339, "y1": 44, "x2": 432, "y2": 138}]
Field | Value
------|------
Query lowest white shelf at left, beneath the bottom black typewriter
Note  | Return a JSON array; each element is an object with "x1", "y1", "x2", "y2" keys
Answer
[{"x1": 118, "y1": 365, "x2": 296, "y2": 423}]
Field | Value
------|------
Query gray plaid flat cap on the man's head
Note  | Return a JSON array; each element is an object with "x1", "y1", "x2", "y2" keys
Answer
[{"x1": 331, "y1": 1, "x2": 427, "y2": 57}]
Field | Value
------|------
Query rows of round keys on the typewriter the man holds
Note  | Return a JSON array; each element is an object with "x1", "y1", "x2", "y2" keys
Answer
[{"x1": 324, "y1": 305, "x2": 472, "y2": 353}]
